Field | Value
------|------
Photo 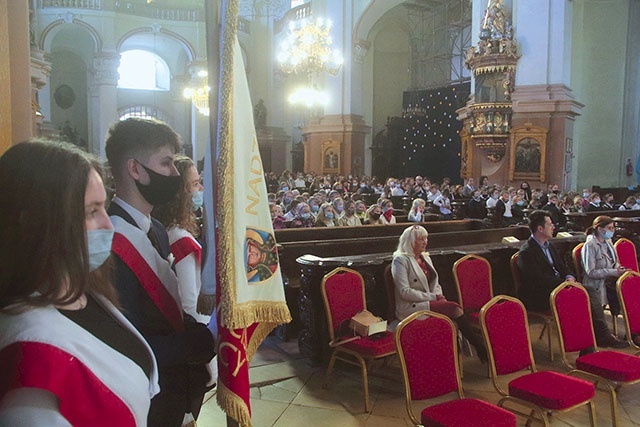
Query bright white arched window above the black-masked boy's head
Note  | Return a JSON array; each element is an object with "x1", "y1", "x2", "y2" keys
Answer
[{"x1": 118, "y1": 50, "x2": 171, "y2": 91}]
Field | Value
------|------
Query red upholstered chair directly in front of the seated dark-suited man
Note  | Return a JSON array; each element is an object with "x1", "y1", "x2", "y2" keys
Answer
[{"x1": 551, "y1": 282, "x2": 640, "y2": 426}]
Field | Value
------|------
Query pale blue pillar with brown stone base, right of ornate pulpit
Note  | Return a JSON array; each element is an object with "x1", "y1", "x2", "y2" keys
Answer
[{"x1": 502, "y1": 0, "x2": 584, "y2": 190}]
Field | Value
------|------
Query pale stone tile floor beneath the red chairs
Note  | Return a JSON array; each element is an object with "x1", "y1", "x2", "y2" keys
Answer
[{"x1": 198, "y1": 325, "x2": 640, "y2": 427}]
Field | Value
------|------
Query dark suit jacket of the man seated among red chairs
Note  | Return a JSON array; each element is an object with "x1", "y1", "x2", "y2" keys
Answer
[{"x1": 518, "y1": 237, "x2": 572, "y2": 311}]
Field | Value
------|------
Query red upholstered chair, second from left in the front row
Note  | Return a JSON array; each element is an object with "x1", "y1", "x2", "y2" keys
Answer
[{"x1": 480, "y1": 295, "x2": 595, "y2": 426}]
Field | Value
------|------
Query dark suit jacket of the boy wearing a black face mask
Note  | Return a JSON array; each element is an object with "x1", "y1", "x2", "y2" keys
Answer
[{"x1": 108, "y1": 203, "x2": 215, "y2": 427}]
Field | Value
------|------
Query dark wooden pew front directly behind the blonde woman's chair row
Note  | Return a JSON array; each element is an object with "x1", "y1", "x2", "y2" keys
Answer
[{"x1": 292, "y1": 227, "x2": 584, "y2": 363}]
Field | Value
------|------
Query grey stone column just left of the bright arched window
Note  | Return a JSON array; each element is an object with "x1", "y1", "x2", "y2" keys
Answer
[{"x1": 88, "y1": 52, "x2": 120, "y2": 160}]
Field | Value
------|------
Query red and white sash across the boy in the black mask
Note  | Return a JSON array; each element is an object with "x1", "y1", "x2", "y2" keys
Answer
[{"x1": 110, "y1": 215, "x2": 184, "y2": 331}]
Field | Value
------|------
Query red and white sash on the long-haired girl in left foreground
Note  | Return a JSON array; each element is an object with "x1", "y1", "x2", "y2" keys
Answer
[{"x1": 0, "y1": 297, "x2": 159, "y2": 427}]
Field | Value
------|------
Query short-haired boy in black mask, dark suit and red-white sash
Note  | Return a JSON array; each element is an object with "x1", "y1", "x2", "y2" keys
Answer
[{"x1": 106, "y1": 118, "x2": 215, "y2": 427}]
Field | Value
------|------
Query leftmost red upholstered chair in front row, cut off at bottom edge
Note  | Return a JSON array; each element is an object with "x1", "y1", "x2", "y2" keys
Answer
[{"x1": 395, "y1": 310, "x2": 516, "y2": 427}]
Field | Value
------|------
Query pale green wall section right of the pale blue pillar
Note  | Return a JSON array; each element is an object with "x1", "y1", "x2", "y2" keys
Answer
[{"x1": 571, "y1": 0, "x2": 629, "y2": 188}]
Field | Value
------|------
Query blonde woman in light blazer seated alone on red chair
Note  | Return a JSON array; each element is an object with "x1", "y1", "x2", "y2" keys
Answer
[{"x1": 391, "y1": 225, "x2": 487, "y2": 363}]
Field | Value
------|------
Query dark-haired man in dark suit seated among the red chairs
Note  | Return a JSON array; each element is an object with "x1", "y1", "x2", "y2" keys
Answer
[{"x1": 518, "y1": 210, "x2": 575, "y2": 311}]
